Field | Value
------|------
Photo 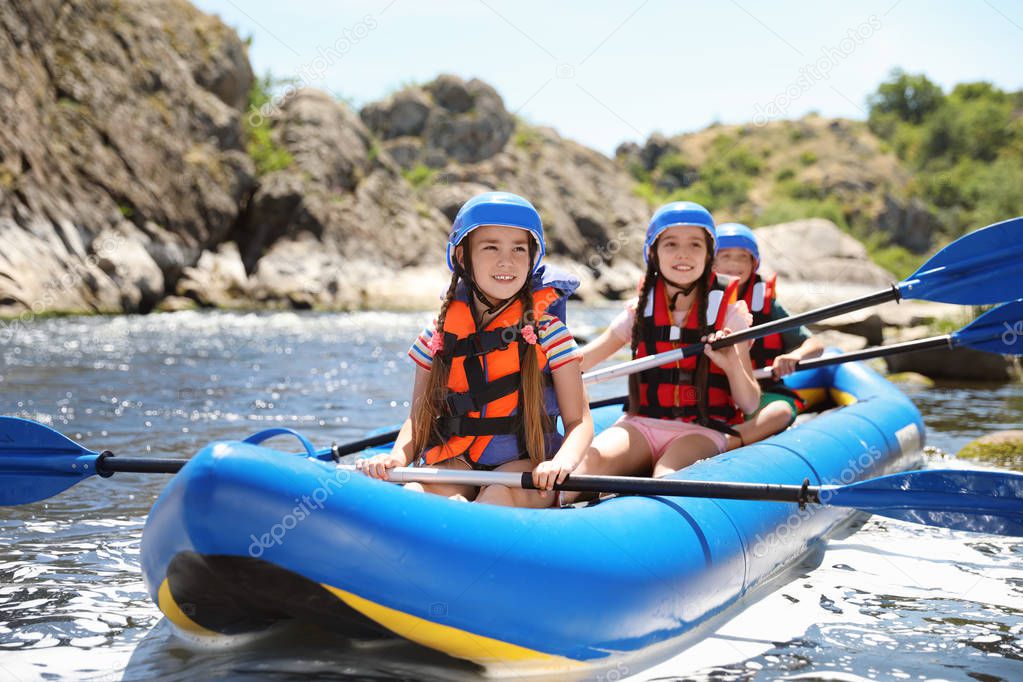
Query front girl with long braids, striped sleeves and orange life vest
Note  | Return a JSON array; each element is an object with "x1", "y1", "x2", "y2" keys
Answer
[{"x1": 356, "y1": 192, "x2": 593, "y2": 507}]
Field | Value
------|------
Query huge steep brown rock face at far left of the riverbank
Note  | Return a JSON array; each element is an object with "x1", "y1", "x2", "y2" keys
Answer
[{"x1": 0, "y1": 0, "x2": 253, "y2": 314}]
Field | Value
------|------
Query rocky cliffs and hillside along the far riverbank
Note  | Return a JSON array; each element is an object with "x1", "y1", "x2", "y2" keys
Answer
[{"x1": 0, "y1": 0, "x2": 982, "y2": 316}]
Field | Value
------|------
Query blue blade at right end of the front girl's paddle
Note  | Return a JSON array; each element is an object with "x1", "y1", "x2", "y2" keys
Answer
[{"x1": 820, "y1": 469, "x2": 1023, "y2": 537}]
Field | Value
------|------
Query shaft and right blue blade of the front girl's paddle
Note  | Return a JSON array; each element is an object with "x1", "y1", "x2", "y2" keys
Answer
[{"x1": 335, "y1": 466, "x2": 1023, "y2": 536}]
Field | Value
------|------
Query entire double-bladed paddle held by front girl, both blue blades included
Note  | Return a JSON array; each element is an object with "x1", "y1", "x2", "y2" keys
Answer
[{"x1": 6, "y1": 417, "x2": 1023, "y2": 536}]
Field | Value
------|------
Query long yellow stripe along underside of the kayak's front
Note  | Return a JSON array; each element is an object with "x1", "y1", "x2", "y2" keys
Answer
[{"x1": 323, "y1": 585, "x2": 585, "y2": 670}]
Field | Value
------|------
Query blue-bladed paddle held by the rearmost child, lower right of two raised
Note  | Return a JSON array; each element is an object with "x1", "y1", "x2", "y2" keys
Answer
[{"x1": 753, "y1": 299, "x2": 1023, "y2": 379}]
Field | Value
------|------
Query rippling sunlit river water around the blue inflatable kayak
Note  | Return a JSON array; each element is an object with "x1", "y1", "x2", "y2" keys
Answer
[{"x1": 0, "y1": 309, "x2": 1023, "y2": 681}]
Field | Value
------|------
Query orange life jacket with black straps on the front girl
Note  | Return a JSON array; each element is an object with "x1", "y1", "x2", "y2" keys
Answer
[{"x1": 421, "y1": 286, "x2": 565, "y2": 468}]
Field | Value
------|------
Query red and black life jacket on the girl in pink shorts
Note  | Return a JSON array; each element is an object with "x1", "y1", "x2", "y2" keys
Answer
[{"x1": 634, "y1": 273, "x2": 743, "y2": 431}]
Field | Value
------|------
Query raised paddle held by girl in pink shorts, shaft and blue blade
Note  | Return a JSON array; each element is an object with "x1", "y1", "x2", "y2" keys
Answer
[{"x1": 583, "y1": 217, "x2": 1023, "y2": 383}]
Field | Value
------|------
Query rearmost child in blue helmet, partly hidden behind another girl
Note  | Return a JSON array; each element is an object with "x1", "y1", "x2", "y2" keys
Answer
[{"x1": 714, "y1": 223, "x2": 824, "y2": 449}]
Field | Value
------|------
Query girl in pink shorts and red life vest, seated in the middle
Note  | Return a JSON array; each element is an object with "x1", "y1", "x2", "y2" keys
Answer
[{"x1": 566, "y1": 201, "x2": 760, "y2": 482}]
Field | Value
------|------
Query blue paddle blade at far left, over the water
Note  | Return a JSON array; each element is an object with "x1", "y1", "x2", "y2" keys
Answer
[{"x1": 0, "y1": 417, "x2": 99, "y2": 506}]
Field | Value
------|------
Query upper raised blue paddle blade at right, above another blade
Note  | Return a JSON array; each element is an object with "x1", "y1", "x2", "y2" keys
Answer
[{"x1": 898, "y1": 217, "x2": 1023, "y2": 306}]
